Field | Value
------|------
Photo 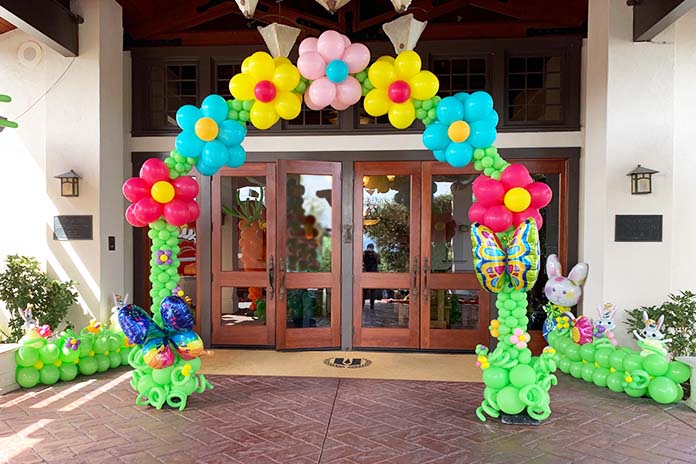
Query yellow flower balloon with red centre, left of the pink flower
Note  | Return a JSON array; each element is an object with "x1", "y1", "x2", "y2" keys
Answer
[{"x1": 230, "y1": 52, "x2": 302, "y2": 130}]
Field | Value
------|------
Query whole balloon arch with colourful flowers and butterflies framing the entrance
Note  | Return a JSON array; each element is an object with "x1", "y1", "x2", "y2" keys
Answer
[{"x1": 119, "y1": 31, "x2": 556, "y2": 420}]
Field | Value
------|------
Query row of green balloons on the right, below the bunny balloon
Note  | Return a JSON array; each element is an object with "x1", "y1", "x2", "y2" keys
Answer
[{"x1": 548, "y1": 329, "x2": 691, "y2": 404}]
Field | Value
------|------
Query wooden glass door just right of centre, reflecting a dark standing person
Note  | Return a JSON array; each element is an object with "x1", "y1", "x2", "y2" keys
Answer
[{"x1": 353, "y1": 162, "x2": 420, "y2": 348}]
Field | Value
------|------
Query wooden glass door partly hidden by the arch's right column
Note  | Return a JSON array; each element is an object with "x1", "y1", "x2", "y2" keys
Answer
[{"x1": 421, "y1": 162, "x2": 489, "y2": 349}]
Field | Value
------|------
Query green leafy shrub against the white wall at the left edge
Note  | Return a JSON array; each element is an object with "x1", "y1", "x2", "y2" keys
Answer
[{"x1": 0, "y1": 255, "x2": 77, "y2": 343}]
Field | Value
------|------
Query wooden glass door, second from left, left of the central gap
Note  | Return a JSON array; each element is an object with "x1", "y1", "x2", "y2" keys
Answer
[{"x1": 277, "y1": 161, "x2": 341, "y2": 349}]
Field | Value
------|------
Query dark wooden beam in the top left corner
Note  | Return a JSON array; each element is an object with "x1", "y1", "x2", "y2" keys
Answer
[{"x1": 0, "y1": 0, "x2": 79, "y2": 56}]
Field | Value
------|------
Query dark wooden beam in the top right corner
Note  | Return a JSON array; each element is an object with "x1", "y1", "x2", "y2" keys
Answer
[{"x1": 633, "y1": 0, "x2": 696, "y2": 42}]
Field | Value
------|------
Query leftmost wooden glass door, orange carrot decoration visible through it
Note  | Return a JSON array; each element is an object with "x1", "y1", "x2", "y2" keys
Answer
[{"x1": 211, "y1": 163, "x2": 276, "y2": 346}]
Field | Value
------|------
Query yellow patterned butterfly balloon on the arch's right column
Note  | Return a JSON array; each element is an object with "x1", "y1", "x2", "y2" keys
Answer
[{"x1": 471, "y1": 218, "x2": 540, "y2": 293}]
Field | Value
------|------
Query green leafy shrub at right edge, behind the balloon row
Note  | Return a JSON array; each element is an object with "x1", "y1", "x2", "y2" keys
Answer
[{"x1": 624, "y1": 291, "x2": 696, "y2": 356}]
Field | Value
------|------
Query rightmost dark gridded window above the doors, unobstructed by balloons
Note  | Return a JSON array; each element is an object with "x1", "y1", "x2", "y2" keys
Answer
[{"x1": 507, "y1": 56, "x2": 563, "y2": 123}]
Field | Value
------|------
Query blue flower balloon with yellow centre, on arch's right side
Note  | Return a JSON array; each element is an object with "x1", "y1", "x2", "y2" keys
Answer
[{"x1": 423, "y1": 92, "x2": 498, "y2": 168}]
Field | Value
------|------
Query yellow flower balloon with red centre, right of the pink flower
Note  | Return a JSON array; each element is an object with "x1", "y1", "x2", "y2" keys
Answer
[{"x1": 363, "y1": 50, "x2": 440, "y2": 129}]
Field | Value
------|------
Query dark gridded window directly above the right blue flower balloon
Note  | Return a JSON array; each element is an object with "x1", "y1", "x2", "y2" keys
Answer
[{"x1": 433, "y1": 57, "x2": 487, "y2": 97}]
